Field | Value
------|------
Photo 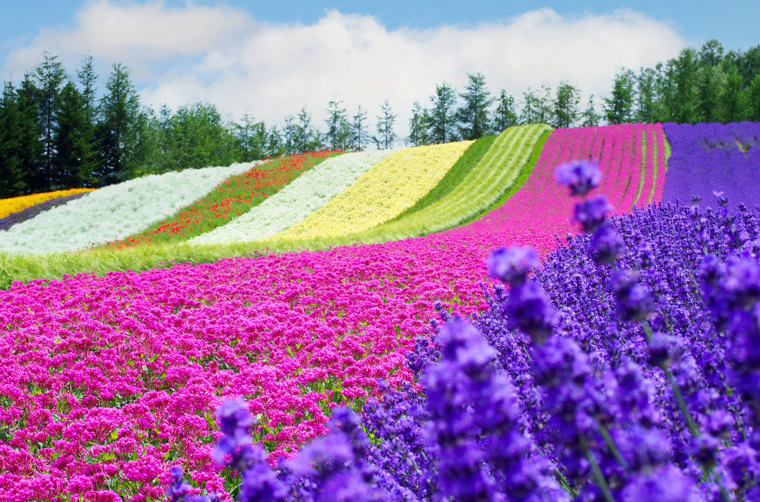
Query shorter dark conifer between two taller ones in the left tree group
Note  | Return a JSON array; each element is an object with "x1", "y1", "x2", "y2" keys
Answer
[{"x1": 53, "y1": 82, "x2": 97, "y2": 188}]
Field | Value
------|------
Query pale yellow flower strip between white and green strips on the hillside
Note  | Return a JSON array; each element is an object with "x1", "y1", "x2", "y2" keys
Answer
[{"x1": 271, "y1": 141, "x2": 472, "y2": 241}]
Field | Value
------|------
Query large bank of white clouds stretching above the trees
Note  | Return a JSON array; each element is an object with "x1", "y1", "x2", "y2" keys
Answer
[{"x1": 3, "y1": 0, "x2": 686, "y2": 138}]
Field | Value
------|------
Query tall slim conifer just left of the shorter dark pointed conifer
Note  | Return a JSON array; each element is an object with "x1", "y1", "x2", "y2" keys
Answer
[{"x1": 35, "y1": 52, "x2": 66, "y2": 190}]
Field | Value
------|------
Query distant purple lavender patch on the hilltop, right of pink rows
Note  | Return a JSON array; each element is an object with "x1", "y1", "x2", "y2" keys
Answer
[{"x1": 662, "y1": 122, "x2": 760, "y2": 210}]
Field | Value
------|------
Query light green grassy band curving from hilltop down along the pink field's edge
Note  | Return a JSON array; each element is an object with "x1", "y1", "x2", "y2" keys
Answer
[{"x1": 0, "y1": 125, "x2": 551, "y2": 289}]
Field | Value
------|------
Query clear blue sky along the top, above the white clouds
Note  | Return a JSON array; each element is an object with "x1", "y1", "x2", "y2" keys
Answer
[{"x1": 0, "y1": 0, "x2": 760, "y2": 50}]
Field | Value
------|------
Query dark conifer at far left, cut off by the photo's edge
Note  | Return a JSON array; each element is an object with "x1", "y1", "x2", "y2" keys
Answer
[{"x1": 0, "y1": 82, "x2": 26, "y2": 198}]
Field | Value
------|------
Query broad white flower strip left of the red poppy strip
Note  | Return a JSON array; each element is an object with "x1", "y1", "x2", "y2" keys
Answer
[{"x1": 0, "y1": 162, "x2": 255, "y2": 254}]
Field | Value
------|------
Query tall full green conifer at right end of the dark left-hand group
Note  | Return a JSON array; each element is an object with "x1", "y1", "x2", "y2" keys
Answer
[{"x1": 96, "y1": 63, "x2": 141, "y2": 185}]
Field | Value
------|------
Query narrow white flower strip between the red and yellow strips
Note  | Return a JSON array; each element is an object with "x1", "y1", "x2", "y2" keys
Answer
[{"x1": 190, "y1": 150, "x2": 391, "y2": 244}]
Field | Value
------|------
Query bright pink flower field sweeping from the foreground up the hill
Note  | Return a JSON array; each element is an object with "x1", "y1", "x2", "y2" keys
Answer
[{"x1": 0, "y1": 126, "x2": 659, "y2": 500}]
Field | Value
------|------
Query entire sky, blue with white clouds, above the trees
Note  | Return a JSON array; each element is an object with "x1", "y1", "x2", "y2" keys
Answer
[{"x1": 0, "y1": 0, "x2": 760, "y2": 135}]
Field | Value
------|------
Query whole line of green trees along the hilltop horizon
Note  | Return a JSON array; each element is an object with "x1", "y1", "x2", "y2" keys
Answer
[{"x1": 0, "y1": 40, "x2": 760, "y2": 197}]
